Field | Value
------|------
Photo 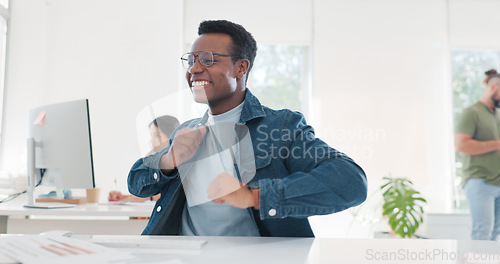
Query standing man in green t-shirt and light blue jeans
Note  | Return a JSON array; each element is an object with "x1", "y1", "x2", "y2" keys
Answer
[{"x1": 455, "y1": 69, "x2": 500, "y2": 240}]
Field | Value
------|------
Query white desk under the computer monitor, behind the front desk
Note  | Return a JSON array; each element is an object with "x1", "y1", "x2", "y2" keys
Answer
[{"x1": 0, "y1": 196, "x2": 153, "y2": 235}]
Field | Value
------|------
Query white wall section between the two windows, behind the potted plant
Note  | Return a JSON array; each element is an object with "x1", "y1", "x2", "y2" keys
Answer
[{"x1": 313, "y1": 0, "x2": 452, "y2": 235}]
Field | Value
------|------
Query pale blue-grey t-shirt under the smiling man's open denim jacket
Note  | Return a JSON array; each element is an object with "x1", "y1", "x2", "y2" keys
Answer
[{"x1": 179, "y1": 103, "x2": 260, "y2": 236}]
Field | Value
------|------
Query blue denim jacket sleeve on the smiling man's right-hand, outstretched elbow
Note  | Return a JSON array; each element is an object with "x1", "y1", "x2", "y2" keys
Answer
[{"x1": 259, "y1": 112, "x2": 367, "y2": 219}]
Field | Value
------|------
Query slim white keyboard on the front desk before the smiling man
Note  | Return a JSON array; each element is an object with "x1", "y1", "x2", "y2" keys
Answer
[{"x1": 89, "y1": 235, "x2": 207, "y2": 249}]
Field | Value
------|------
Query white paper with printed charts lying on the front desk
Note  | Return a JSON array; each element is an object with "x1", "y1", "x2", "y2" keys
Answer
[{"x1": 0, "y1": 235, "x2": 133, "y2": 264}]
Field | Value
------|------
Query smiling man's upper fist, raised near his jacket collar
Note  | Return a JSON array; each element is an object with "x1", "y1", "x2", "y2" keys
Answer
[{"x1": 160, "y1": 126, "x2": 207, "y2": 172}]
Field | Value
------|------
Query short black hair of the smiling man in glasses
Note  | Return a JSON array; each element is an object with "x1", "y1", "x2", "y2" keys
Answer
[{"x1": 198, "y1": 20, "x2": 257, "y2": 81}]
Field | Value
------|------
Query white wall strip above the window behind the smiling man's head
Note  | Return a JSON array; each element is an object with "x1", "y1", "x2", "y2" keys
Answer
[{"x1": 184, "y1": 0, "x2": 313, "y2": 45}]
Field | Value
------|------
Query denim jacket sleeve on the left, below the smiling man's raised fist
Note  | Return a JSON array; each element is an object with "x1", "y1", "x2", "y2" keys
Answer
[{"x1": 127, "y1": 147, "x2": 179, "y2": 197}]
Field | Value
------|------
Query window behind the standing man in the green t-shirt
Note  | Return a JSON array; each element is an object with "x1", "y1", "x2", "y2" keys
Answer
[{"x1": 451, "y1": 50, "x2": 500, "y2": 208}]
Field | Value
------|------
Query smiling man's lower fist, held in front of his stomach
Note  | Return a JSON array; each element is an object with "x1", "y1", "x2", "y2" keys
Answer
[{"x1": 207, "y1": 172, "x2": 257, "y2": 209}]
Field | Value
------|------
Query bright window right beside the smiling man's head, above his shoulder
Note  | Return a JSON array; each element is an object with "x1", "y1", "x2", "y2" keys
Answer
[{"x1": 247, "y1": 44, "x2": 309, "y2": 112}]
